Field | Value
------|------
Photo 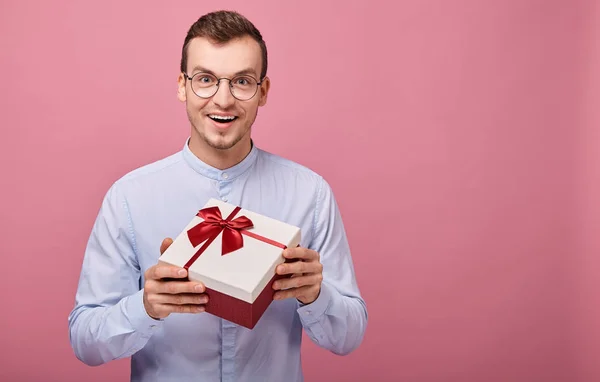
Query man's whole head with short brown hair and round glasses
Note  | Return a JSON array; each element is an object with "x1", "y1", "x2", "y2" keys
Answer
[{"x1": 178, "y1": 11, "x2": 270, "y2": 156}]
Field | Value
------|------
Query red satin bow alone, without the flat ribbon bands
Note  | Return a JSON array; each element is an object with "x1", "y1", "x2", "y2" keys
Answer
[{"x1": 187, "y1": 207, "x2": 253, "y2": 256}]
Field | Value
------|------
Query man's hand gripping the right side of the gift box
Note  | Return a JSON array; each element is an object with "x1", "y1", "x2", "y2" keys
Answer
[{"x1": 273, "y1": 247, "x2": 323, "y2": 304}]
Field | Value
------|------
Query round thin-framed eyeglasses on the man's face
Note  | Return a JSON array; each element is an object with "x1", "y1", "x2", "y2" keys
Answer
[{"x1": 183, "y1": 72, "x2": 262, "y2": 101}]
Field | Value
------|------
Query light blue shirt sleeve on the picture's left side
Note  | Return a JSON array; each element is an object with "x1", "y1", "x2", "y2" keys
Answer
[{"x1": 68, "y1": 184, "x2": 163, "y2": 366}]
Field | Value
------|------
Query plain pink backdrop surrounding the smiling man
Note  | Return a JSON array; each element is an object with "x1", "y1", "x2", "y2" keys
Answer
[{"x1": 0, "y1": 0, "x2": 600, "y2": 382}]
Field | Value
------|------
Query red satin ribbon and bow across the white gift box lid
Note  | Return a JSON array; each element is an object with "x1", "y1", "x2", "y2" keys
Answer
[{"x1": 184, "y1": 207, "x2": 287, "y2": 269}]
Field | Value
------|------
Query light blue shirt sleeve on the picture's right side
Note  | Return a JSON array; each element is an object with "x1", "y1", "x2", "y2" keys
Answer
[{"x1": 298, "y1": 180, "x2": 368, "y2": 355}]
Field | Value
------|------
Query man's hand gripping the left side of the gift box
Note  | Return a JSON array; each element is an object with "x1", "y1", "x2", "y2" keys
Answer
[{"x1": 144, "y1": 238, "x2": 208, "y2": 319}]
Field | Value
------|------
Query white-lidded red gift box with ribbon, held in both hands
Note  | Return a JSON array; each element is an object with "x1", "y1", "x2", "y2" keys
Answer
[{"x1": 159, "y1": 199, "x2": 301, "y2": 329}]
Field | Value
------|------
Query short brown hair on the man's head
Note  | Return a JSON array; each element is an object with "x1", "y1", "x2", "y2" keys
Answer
[{"x1": 180, "y1": 11, "x2": 267, "y2": 81}]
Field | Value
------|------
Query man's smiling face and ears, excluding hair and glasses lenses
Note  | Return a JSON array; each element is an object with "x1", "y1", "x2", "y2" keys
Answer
[{"x1": 178, "y1": 37, "x2": 269, "y2": 150}]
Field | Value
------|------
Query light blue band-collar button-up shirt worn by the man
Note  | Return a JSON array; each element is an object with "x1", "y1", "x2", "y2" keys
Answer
[{"x1": 68, "y1": 141, "x2": 367, "y2": 382}]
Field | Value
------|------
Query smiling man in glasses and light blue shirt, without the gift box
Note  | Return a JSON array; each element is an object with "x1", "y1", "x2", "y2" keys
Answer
[{"x1": 69, "y1": 8, "x2": 367, "y2": 382}]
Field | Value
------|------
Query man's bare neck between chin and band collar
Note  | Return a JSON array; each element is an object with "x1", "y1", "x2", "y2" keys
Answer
[{"x1": 189, "y1": 137, "x2": 252, "y2": 170}]
